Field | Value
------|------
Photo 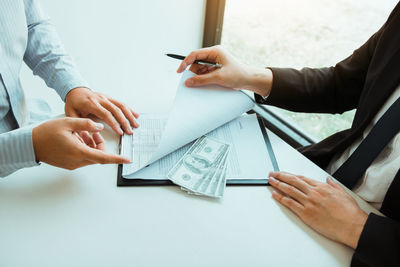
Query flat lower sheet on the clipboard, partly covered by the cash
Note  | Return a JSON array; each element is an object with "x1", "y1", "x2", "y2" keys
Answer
[{"x1": 124, "y1": 114, "x2": 273, "y2": 180}]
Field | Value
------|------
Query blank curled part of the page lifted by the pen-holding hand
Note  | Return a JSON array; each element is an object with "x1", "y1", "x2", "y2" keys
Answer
[{"x1": 122, "y1": 71, "x2": 254, "y2": 177}]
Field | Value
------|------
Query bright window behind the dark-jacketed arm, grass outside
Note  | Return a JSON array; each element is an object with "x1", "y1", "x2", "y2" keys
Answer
[{"x1": 221, "y1": 0, "x2": 397, "y2": 140}]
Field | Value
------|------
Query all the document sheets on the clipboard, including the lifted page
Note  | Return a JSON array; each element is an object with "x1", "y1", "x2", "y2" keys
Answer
[{"x1": 122, "y1": 71, "x2": 272, "y2": 179}]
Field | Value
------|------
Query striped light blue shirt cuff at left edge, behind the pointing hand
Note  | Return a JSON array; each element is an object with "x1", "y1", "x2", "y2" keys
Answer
[{"x1": 0, "y1": 126, "x2": 39, "y2": 177}]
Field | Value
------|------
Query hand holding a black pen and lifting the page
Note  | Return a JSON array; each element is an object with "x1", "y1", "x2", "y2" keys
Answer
[{"x1": 177, "y1": 46, "x2": 273, "y2": 96}]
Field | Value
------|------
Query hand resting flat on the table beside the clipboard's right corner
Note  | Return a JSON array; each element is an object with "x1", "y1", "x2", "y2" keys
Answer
[{"x1": 269, "y1": 172, "x2": 368, "y2": 248}]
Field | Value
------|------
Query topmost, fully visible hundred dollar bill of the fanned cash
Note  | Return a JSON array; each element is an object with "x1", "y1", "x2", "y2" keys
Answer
[{"x1": 167, "y1": 136, "x2": 229, "y2": 197}]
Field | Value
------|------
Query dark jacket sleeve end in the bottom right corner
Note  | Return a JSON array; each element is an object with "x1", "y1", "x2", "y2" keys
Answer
[{"x1": 351, "y1": 213, "x2": 400, "y2": 267}]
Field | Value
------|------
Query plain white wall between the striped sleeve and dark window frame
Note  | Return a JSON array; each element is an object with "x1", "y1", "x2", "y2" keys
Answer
[{"x1": 21, "y1": 0, "x2": 205, "y2": 114}]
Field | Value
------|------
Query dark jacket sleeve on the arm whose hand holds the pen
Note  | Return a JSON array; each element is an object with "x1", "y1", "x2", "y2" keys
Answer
[{"x1": 256, "y1": 24, "x2": 386, "y2": 113}]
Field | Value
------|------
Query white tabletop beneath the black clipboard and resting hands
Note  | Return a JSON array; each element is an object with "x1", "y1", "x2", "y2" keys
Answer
[{"x1": 0, "y1": 126, "x2": 382, "y2": 267}]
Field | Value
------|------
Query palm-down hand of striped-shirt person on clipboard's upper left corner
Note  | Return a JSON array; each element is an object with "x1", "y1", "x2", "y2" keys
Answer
[{"x1": 65, "y1": 87, "x2": 139, "y2": 135}]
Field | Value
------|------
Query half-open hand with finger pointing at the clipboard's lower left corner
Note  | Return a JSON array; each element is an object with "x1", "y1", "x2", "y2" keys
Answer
[{"x1": 32, "y1": 118, "x2": 130, "y2": 170}]
